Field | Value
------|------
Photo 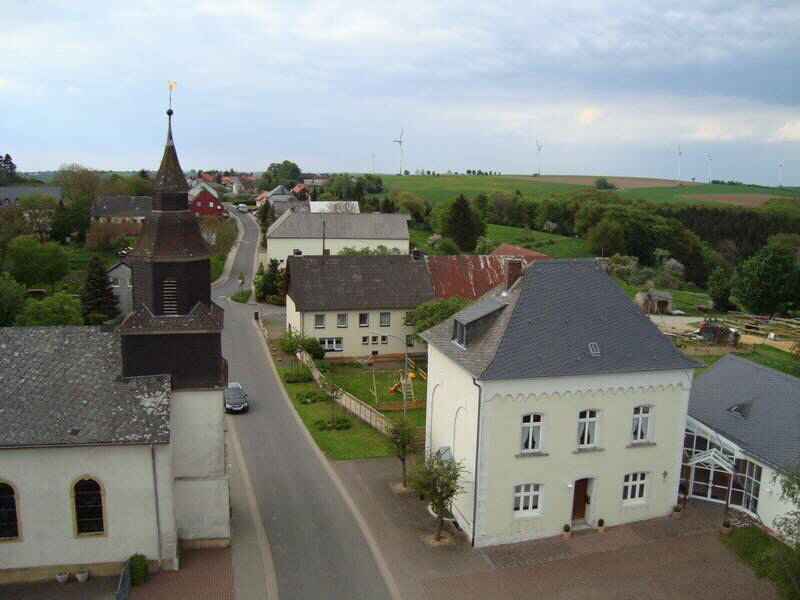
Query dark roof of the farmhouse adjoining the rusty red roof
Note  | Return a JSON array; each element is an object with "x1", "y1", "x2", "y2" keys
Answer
[{"x1": 286, "y1": 254, "x2": 434, "y2": 311}]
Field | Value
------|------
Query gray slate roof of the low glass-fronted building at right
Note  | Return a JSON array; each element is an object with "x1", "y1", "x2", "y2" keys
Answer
[{"x1": 689, "y1": 354, "x2": 800, "y2": 467}]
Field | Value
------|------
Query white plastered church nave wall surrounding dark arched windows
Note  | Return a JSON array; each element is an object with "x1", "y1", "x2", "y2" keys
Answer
[{"x1": 0, "y1": 445, "x2": 177, "y2": 583}]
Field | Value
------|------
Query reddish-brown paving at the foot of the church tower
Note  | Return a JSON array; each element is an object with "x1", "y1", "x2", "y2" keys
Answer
[{"x1": 130, "y1": 548, "x2": 233, "y2": 600}]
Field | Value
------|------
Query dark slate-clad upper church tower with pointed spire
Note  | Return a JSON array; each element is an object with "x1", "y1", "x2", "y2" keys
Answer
[{"x1": 120, "y1": 108, "x2": 227, "y2": 389}]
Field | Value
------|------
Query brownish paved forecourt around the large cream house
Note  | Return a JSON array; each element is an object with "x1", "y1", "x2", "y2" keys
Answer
[{"x1": 333, "y1": 458, "x2": 776, "y2": 600}]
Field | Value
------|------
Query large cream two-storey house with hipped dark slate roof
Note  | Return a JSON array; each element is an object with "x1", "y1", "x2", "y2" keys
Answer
[{"x1": 423, "y1": 260, "x2": 699, "y2": 546}]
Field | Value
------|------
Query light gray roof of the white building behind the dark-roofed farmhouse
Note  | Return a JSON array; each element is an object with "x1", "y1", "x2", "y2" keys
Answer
[{"x1": 267, "y1": 210, "x2": 408, "y2": 241}]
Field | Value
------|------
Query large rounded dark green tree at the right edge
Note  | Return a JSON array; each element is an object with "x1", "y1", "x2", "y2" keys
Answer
[{"x1": 731, "y1": 245, "x2": 800, "y2": 314}]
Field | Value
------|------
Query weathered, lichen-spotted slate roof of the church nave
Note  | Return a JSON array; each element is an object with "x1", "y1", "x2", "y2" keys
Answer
[{"x1": 0, "y1": 327, "x2": 170, "y2": 448}]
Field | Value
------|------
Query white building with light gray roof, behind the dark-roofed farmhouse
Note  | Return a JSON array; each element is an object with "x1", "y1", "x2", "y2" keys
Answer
[{"x1": 266, "y1": 209, "x2": 409, "y2": 260}]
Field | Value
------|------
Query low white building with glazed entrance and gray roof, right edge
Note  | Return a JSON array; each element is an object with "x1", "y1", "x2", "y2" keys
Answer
[{"x1": 682, "y1": 354, "x2": 800, "y2": 530}]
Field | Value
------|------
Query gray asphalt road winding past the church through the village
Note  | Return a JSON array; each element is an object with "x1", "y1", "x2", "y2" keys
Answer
[{"x1": 211, "y1": 212, "x2": 390, "y2": 600}]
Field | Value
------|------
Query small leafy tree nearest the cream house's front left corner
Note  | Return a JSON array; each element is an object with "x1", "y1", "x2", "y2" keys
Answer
[{"x1": 409, "y1": 452, "x2": 466, "y2": 541}]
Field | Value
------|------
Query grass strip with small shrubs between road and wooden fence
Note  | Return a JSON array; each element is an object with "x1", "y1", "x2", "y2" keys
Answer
[{"x1": 277, "y1": 366, "x2": 394, "y2": 460}]
